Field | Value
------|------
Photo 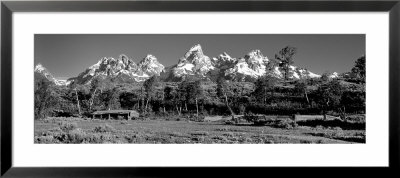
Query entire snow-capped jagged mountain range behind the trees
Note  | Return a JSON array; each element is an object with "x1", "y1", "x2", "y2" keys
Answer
[{"x1": 35, "y1": 44, "x2": 338, "y2": 85}]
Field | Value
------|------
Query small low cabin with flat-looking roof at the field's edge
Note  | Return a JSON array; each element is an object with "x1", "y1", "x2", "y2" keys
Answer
[{"x1": 92, "y1": 110, "x2": 139, "y2": 120}]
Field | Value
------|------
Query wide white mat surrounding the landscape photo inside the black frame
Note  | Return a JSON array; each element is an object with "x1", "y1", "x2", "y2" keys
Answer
[{"x1": 12, "y1": 12, "x2": 389, "y2": 167}]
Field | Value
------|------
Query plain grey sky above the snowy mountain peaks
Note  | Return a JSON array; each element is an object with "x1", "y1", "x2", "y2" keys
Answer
[{"x1": 35, "y1": 34, "x2": 365, "y2": 79}]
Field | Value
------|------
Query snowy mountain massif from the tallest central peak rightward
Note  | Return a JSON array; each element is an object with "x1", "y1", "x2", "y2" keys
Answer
[{"x1": 167, "y1": 44, "x2": 320, "y2": 81}]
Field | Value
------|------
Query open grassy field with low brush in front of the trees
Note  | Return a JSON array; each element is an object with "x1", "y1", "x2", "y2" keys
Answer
[{"x1": 34, "y1": 118, "x2": 365, "y2": 144}]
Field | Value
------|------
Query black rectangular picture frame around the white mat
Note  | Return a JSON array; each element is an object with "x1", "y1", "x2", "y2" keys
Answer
[{"x1": 0, "y1": 0, "x2": 400, "y2": 177}]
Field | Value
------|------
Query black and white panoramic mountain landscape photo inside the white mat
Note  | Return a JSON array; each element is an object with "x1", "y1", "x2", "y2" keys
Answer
[{"x1": 32, "y1": 34, "x2": 366, "y2": 144}]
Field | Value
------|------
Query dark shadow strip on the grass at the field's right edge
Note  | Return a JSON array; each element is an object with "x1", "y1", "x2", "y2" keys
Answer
[{"x1": 297, "y1": 119, "x2": 365, "y2": 130}]
